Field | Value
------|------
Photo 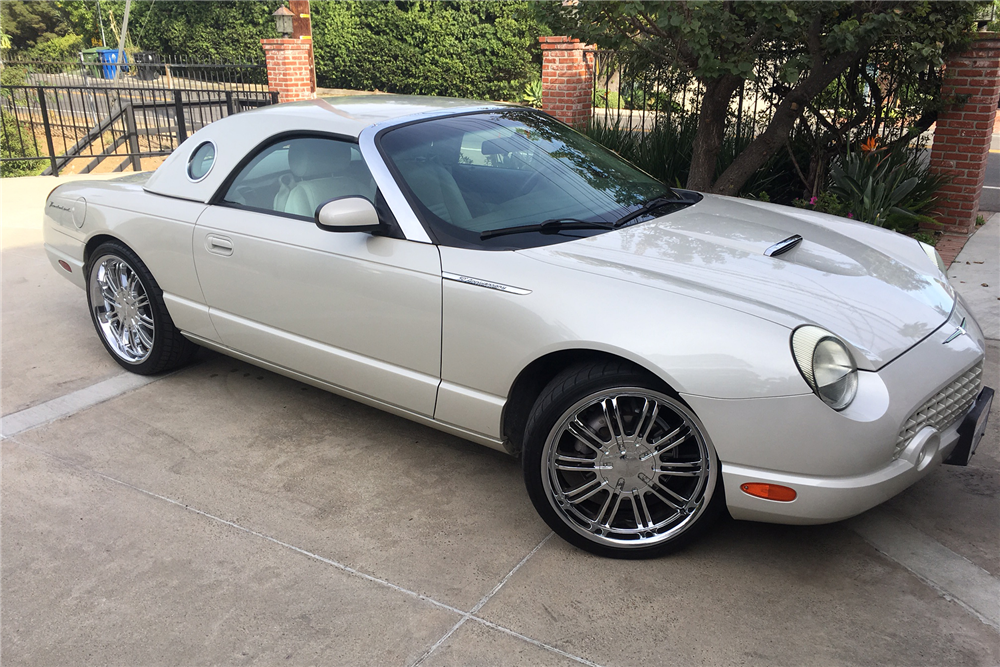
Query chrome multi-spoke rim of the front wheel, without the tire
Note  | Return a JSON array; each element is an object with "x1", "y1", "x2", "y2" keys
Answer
[{"x1": 541, "y1": 387, "x2": 718, "y2": 549}]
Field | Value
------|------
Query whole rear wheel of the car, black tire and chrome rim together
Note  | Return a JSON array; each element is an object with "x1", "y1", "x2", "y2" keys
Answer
[{"x1": 86, "y1": 241, "x2": 198, "y2": 375}]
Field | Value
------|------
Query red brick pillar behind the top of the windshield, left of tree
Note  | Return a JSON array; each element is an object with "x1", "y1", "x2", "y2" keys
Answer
[{"x1": 538, "y1": 37, "x2": 594, "y2": 127}]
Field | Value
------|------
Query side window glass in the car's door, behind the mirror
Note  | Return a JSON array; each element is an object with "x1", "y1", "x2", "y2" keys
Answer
[{"x1": 223, "y1": 137, "x2": 375, "y2": 218}]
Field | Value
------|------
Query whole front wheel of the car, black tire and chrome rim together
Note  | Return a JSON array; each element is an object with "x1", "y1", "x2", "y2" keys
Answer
[{"x1": 522, "y1": 360, "x2": 725, "y2": 558}]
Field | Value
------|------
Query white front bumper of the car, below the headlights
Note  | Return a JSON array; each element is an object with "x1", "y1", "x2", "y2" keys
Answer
[{"x1": 684, "y1": 303, "x2": 985, "y2": 524}]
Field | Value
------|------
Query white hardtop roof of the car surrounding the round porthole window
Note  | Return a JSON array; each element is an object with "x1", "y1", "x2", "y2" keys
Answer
[{"x1": 144, "y1": 94, "x2": 507, "y2": 202}]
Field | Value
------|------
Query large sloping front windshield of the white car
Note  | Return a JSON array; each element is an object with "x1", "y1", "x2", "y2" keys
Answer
[{"x1": 379, "y1": 109, "x2": 690, "y2": 249}]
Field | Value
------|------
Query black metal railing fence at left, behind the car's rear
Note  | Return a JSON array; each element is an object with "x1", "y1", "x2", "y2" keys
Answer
[{"x1": 0, "y1": 54, "x2": 278, "y2": 175}]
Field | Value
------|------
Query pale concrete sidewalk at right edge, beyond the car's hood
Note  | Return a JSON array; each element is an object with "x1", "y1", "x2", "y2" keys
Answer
[{"x1": 948, "y1": 213, "x2": 1000, "y2": 340}]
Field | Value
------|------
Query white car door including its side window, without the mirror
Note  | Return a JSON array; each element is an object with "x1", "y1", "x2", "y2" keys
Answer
[{"x1": 194, "y1": 136, "x2": 441, "y2": 416}]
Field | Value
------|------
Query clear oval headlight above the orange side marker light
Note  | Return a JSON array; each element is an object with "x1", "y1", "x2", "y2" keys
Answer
[{"x1": 792, "y1": 326, "x2": 858, "y2": 410}]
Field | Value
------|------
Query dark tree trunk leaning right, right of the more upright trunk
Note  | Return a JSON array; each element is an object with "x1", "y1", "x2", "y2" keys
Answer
[{"x1": 712, "y1": 48, "x2": 867, "y2": 195}]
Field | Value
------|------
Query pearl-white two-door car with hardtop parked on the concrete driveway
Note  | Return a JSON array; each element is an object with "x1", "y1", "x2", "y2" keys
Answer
[{"x1": 45, "y1": 96, "x2": 993, "y2": 557}]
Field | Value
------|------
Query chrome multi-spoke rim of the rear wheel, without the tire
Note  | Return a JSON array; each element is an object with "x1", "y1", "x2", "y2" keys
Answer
[{"x1": 89, "y1": 255, "x2": 156, "y2": 364}]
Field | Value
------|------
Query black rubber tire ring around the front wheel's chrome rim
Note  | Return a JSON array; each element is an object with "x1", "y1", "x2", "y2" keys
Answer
[{"x1": 522, "y1": 371, "x2": 725, "y2": 559}]
